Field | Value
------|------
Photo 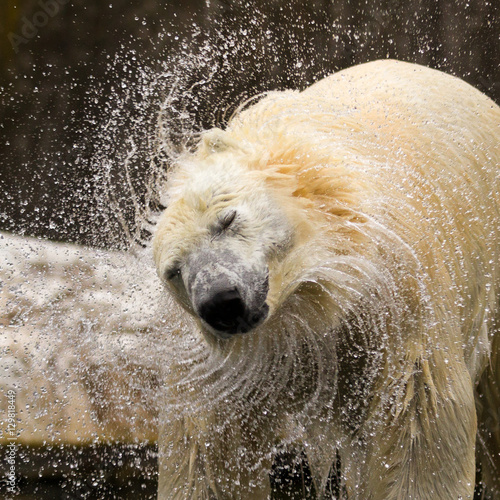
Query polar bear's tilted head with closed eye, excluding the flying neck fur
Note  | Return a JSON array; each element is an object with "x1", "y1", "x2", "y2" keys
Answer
[{"x1": 153, "y1": 131, "x2": 304, "y2": 338}]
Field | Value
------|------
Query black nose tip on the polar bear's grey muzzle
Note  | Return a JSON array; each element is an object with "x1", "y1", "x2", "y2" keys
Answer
[{"x1": 199, "y1": 288, "x2": 249, "y2": 333}]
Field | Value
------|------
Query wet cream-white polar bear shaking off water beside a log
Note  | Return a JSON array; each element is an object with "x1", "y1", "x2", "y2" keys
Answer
[{"x1": 153, "y1": 60, "x2": 500, "y2": 500}]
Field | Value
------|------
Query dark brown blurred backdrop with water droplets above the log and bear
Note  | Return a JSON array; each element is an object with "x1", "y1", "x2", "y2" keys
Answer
[{"x1": 0, "y1": 0, "x2": 500, "y2": 247}]
